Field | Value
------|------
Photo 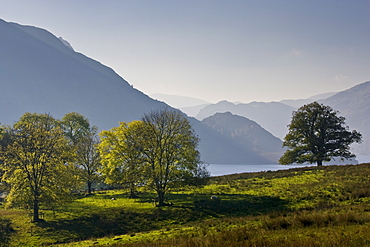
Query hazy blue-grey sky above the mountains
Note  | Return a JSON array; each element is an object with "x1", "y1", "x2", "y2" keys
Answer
[{"x1": 0, "y1": 0, "x2": 370, "y2": 103}]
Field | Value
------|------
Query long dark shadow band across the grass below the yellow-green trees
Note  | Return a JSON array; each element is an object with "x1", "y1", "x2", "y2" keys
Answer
[{"x1": 34, "y1": 194, "x2": 286, "y2": 243}]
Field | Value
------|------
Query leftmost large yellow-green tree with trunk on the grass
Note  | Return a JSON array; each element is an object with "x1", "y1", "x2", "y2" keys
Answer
[{"x1": 1, "y1": 113, "x2": 73, "y2": 222}]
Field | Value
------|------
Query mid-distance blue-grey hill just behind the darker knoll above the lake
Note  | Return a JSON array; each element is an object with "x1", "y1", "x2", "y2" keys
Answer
[{"x1": 202, "y1": 112, "x2": 284, "y2": 163}]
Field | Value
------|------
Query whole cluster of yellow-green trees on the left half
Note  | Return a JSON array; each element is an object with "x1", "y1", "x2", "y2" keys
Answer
[{"x1": 0, "y1": 109, "x2": 209, "y2": 222}]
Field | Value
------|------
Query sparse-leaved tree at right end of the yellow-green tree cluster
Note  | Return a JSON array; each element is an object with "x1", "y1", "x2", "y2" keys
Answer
[{"x1": 139, "y1": 109, "x2": 200, "y2": 206}]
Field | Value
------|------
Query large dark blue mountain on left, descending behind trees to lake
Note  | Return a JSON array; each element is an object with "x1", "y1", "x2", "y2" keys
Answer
[{"x1": 0, "y1": 19, "x2": 272, "y2": 164}]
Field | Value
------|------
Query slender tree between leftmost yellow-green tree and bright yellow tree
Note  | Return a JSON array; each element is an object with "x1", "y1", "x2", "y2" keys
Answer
[{"x1": 62, "y1": 112, "x2": 101, "y2": 194}]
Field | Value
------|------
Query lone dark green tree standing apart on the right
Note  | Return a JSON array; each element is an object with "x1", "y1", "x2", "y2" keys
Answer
[{"x1": 279, "y1": 102, "x2": 362, "y2": 166}]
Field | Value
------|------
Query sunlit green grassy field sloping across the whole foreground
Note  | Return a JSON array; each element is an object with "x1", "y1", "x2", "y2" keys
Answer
[{"x1": 0, "y1": 164, "x2": 370, "y2": 247}]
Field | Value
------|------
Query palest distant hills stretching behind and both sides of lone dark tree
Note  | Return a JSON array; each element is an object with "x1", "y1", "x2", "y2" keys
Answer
[{"x1": 192, "y1": 81, "x2": 370, "y2": 155}]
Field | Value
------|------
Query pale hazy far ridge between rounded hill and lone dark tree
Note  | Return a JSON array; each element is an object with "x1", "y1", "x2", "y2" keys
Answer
[{"x1": 196, "y1": 101, "x2": 296, "y2": 139}]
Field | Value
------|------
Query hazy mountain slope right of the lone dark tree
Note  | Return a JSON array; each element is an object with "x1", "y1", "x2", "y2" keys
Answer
[{"x1": 321, "y1": 81, "x2": 370, "y2": 155}]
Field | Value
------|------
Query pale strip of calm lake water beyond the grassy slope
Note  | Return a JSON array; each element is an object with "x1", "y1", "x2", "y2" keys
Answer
[{"x1": 207, "y1": 156, "x2": 370, "y2": 176}]
